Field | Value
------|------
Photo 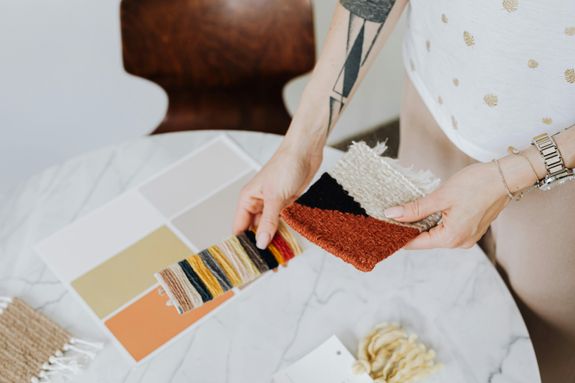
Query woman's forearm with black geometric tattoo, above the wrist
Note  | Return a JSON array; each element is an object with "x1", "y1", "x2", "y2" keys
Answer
[{"x1": 285, "y1": 0, "x2": 407, "y2": 153}]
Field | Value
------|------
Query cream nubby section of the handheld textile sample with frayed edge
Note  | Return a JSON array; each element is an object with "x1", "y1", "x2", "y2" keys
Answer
[{"x1": 328, "y1": 142, "x2": 441, "y2": 231}]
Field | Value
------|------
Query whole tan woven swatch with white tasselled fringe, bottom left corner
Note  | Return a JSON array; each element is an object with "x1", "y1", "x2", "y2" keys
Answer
[{"x1": 0, "y1": 297, "x2": 102, "y2": 383}]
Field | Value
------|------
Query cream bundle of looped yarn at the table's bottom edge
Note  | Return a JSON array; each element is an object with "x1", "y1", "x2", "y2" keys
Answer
[{"x1": 353, "y1": 323, "x2": 441, "y2": 383}]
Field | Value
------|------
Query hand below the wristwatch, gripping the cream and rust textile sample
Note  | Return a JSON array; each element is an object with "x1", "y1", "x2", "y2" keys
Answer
[{"x1": 385, "y1": 162, "x2": 509, "y2": 249}]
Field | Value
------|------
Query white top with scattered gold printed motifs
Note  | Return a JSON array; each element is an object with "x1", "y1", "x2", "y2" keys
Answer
[{"x1": 404, "y1": 0, "x2": 575, "y2": 161}]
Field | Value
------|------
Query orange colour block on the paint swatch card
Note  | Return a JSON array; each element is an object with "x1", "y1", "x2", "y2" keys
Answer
[{"x1": 105, "y1": 288, "x2": 234, "y2": 362}]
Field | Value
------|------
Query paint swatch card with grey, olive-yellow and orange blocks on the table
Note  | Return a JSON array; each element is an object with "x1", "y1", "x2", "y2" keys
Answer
[{"x1": 37, "y1": 135, "x2": 259, "y2": 362}]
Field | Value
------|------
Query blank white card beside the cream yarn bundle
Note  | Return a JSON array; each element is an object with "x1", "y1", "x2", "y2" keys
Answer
[{"x1": 273, "y1": 335, "x2": 373, "y2": 383}]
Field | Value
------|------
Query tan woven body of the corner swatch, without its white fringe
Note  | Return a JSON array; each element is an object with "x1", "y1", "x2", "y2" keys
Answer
[{"x1": 0, "y1": 299, "x2": 71, "y2": 383}]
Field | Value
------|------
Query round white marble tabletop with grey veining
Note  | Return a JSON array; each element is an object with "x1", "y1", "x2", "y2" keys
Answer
[{"x1": 0, "y1": 131, "x2": 540, "y2": 383}]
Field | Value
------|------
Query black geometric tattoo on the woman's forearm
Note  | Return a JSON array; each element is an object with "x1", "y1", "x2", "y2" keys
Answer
[{"x1": 328, "y1": 0, "x2": 395, "y2": 133}]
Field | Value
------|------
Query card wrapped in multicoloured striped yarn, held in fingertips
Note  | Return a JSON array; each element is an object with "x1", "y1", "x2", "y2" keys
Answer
[{"x1": 154, "y1": 223, "x2": 301, "y2": 314}]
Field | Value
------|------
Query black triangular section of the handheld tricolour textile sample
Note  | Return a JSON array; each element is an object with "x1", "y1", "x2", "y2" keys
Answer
[{"x1": 296, "y1": 173, "x2": 367, "y2": 217}]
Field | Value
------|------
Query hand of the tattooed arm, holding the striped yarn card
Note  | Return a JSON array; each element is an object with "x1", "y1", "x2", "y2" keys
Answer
[{"x1": 234, "y1": 139, "x2": 323, "y2": 249}]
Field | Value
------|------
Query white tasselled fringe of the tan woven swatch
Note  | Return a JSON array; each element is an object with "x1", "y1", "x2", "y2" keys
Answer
[{"x1": 30, "y1": 338, "x2": 104, "y2": 383}]
